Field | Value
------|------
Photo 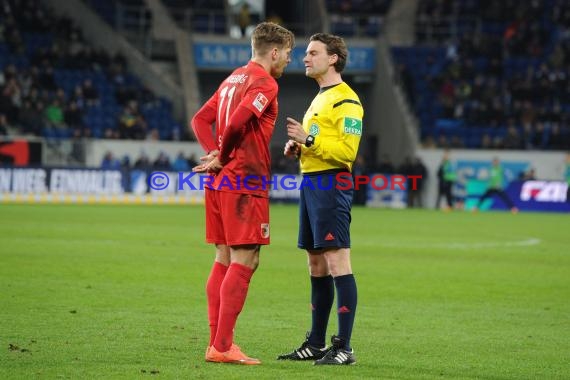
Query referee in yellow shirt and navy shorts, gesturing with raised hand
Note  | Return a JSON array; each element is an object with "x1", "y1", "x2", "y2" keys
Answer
[{"x1": 278, "y1": 33, "x2": 364, "y2": 365}]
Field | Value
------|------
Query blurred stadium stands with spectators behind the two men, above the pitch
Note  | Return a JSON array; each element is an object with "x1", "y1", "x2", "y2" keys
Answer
[{"x1": 0, "y1": 0, "x2": 570, "y2": 211}]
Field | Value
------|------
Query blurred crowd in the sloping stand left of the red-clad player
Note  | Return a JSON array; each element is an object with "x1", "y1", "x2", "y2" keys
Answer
[{"x1": 0, "y1": 0, "x2": 180, "y2": 140}]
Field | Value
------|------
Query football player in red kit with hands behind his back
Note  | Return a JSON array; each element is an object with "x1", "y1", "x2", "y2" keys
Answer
[{"x1": 192, "y1": 22, "x2": 295, "y2": 364}]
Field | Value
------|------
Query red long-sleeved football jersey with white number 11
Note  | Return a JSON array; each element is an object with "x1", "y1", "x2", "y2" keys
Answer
[{"x1": 203, "y1": 61, "x2": 278, "y2": 197}]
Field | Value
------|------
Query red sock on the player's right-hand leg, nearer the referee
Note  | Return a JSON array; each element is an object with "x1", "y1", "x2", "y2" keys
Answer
[{"x1": 214, "y1": 263, "x2": 253, "y2": 352}]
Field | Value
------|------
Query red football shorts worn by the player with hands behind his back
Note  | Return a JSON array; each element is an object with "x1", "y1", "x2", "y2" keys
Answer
[{"x1": 205, "y1": 188, "x2": 269, "y2": 246}]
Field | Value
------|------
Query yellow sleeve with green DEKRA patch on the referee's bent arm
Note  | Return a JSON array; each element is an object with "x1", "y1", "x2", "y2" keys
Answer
[{"x1": 301, "y1": 103, "x2": 364, "y2": 166}]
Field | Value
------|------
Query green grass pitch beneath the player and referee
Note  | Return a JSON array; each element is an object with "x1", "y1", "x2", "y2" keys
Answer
[{"x1": 0, "y1": 205, "x2": 570, "y2": 380}]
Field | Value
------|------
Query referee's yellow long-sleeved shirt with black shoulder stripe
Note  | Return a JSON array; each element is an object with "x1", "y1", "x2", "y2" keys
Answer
[{"x1": 300, "y1": 82, "x2": 364, "y2": 173}]
